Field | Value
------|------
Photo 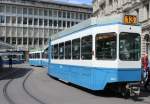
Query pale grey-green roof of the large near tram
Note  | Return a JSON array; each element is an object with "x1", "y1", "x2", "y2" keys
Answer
[{"x1": 51, "y1": 14, "x2": 139, "y2": 40}]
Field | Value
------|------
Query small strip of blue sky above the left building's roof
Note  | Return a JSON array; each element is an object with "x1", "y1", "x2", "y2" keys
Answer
[{"x1": 56, "y1": 0, "x2": 92, "y2": 4}]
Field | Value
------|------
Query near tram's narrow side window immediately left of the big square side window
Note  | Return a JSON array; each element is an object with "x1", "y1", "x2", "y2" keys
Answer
[{"x1": 81, "y1": 35, "x2": 92, "y2": 60}]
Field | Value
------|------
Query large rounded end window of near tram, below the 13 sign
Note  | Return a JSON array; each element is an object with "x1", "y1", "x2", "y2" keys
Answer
[{"x1": 119, "y1": 32, "x2": 141, "y2": 61}]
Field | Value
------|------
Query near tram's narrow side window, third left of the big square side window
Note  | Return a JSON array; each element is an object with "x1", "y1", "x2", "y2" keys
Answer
[{"x1": 65, "y1": 41, "x2": 71, "y2": 59}]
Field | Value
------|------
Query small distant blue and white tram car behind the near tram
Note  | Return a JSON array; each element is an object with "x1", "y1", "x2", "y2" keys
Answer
[{"x1": 29, "y1": 51, "x2": 43, "y2": 66}]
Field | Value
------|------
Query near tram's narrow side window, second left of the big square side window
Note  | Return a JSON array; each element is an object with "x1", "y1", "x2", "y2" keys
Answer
[{"x1": 72, "y1": 38, "x2": 80, "y2": 59}]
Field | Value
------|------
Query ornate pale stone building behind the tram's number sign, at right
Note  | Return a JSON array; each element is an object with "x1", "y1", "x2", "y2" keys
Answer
[{"x1": 93, "y1": 0, "x2": 150, "y2": 55}]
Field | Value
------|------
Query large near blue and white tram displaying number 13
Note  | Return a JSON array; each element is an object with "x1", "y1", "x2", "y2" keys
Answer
[{"x1": 48, "y1": 16, "x2": 141, "y2": 94}]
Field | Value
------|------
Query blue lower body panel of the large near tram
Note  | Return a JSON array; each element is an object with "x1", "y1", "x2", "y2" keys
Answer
[{"x1": 48, "y1": 64, "x2": 141, "y2": 90}]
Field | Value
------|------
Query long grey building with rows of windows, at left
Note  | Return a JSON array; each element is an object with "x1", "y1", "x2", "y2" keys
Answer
[{"x1": 0, "y1": 0, "x2": 92, "y2": 51}]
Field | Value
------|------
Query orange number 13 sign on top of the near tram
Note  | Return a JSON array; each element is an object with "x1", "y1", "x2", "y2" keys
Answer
[{"x1": 124, "y1": 15, "x2": 137, "y2": 25}]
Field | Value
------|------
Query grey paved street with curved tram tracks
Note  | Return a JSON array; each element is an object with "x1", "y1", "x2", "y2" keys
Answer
[{"x1": 0, "y1": 64, "x2": 150, "y2": 104}]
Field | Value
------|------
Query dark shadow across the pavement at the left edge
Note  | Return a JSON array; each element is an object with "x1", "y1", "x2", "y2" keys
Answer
[{"x1": 0, "y1": 67, "x2": 32, "y2": 81}]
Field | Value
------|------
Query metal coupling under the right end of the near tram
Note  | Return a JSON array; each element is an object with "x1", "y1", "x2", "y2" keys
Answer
[{"x1": 126, "y1": 82, "x2": 140, "y2": 96}]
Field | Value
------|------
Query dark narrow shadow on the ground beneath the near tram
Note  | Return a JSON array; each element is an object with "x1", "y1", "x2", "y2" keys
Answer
[{"x1": 48, "y1": 75, "x2": 150, "y2": 104}]
